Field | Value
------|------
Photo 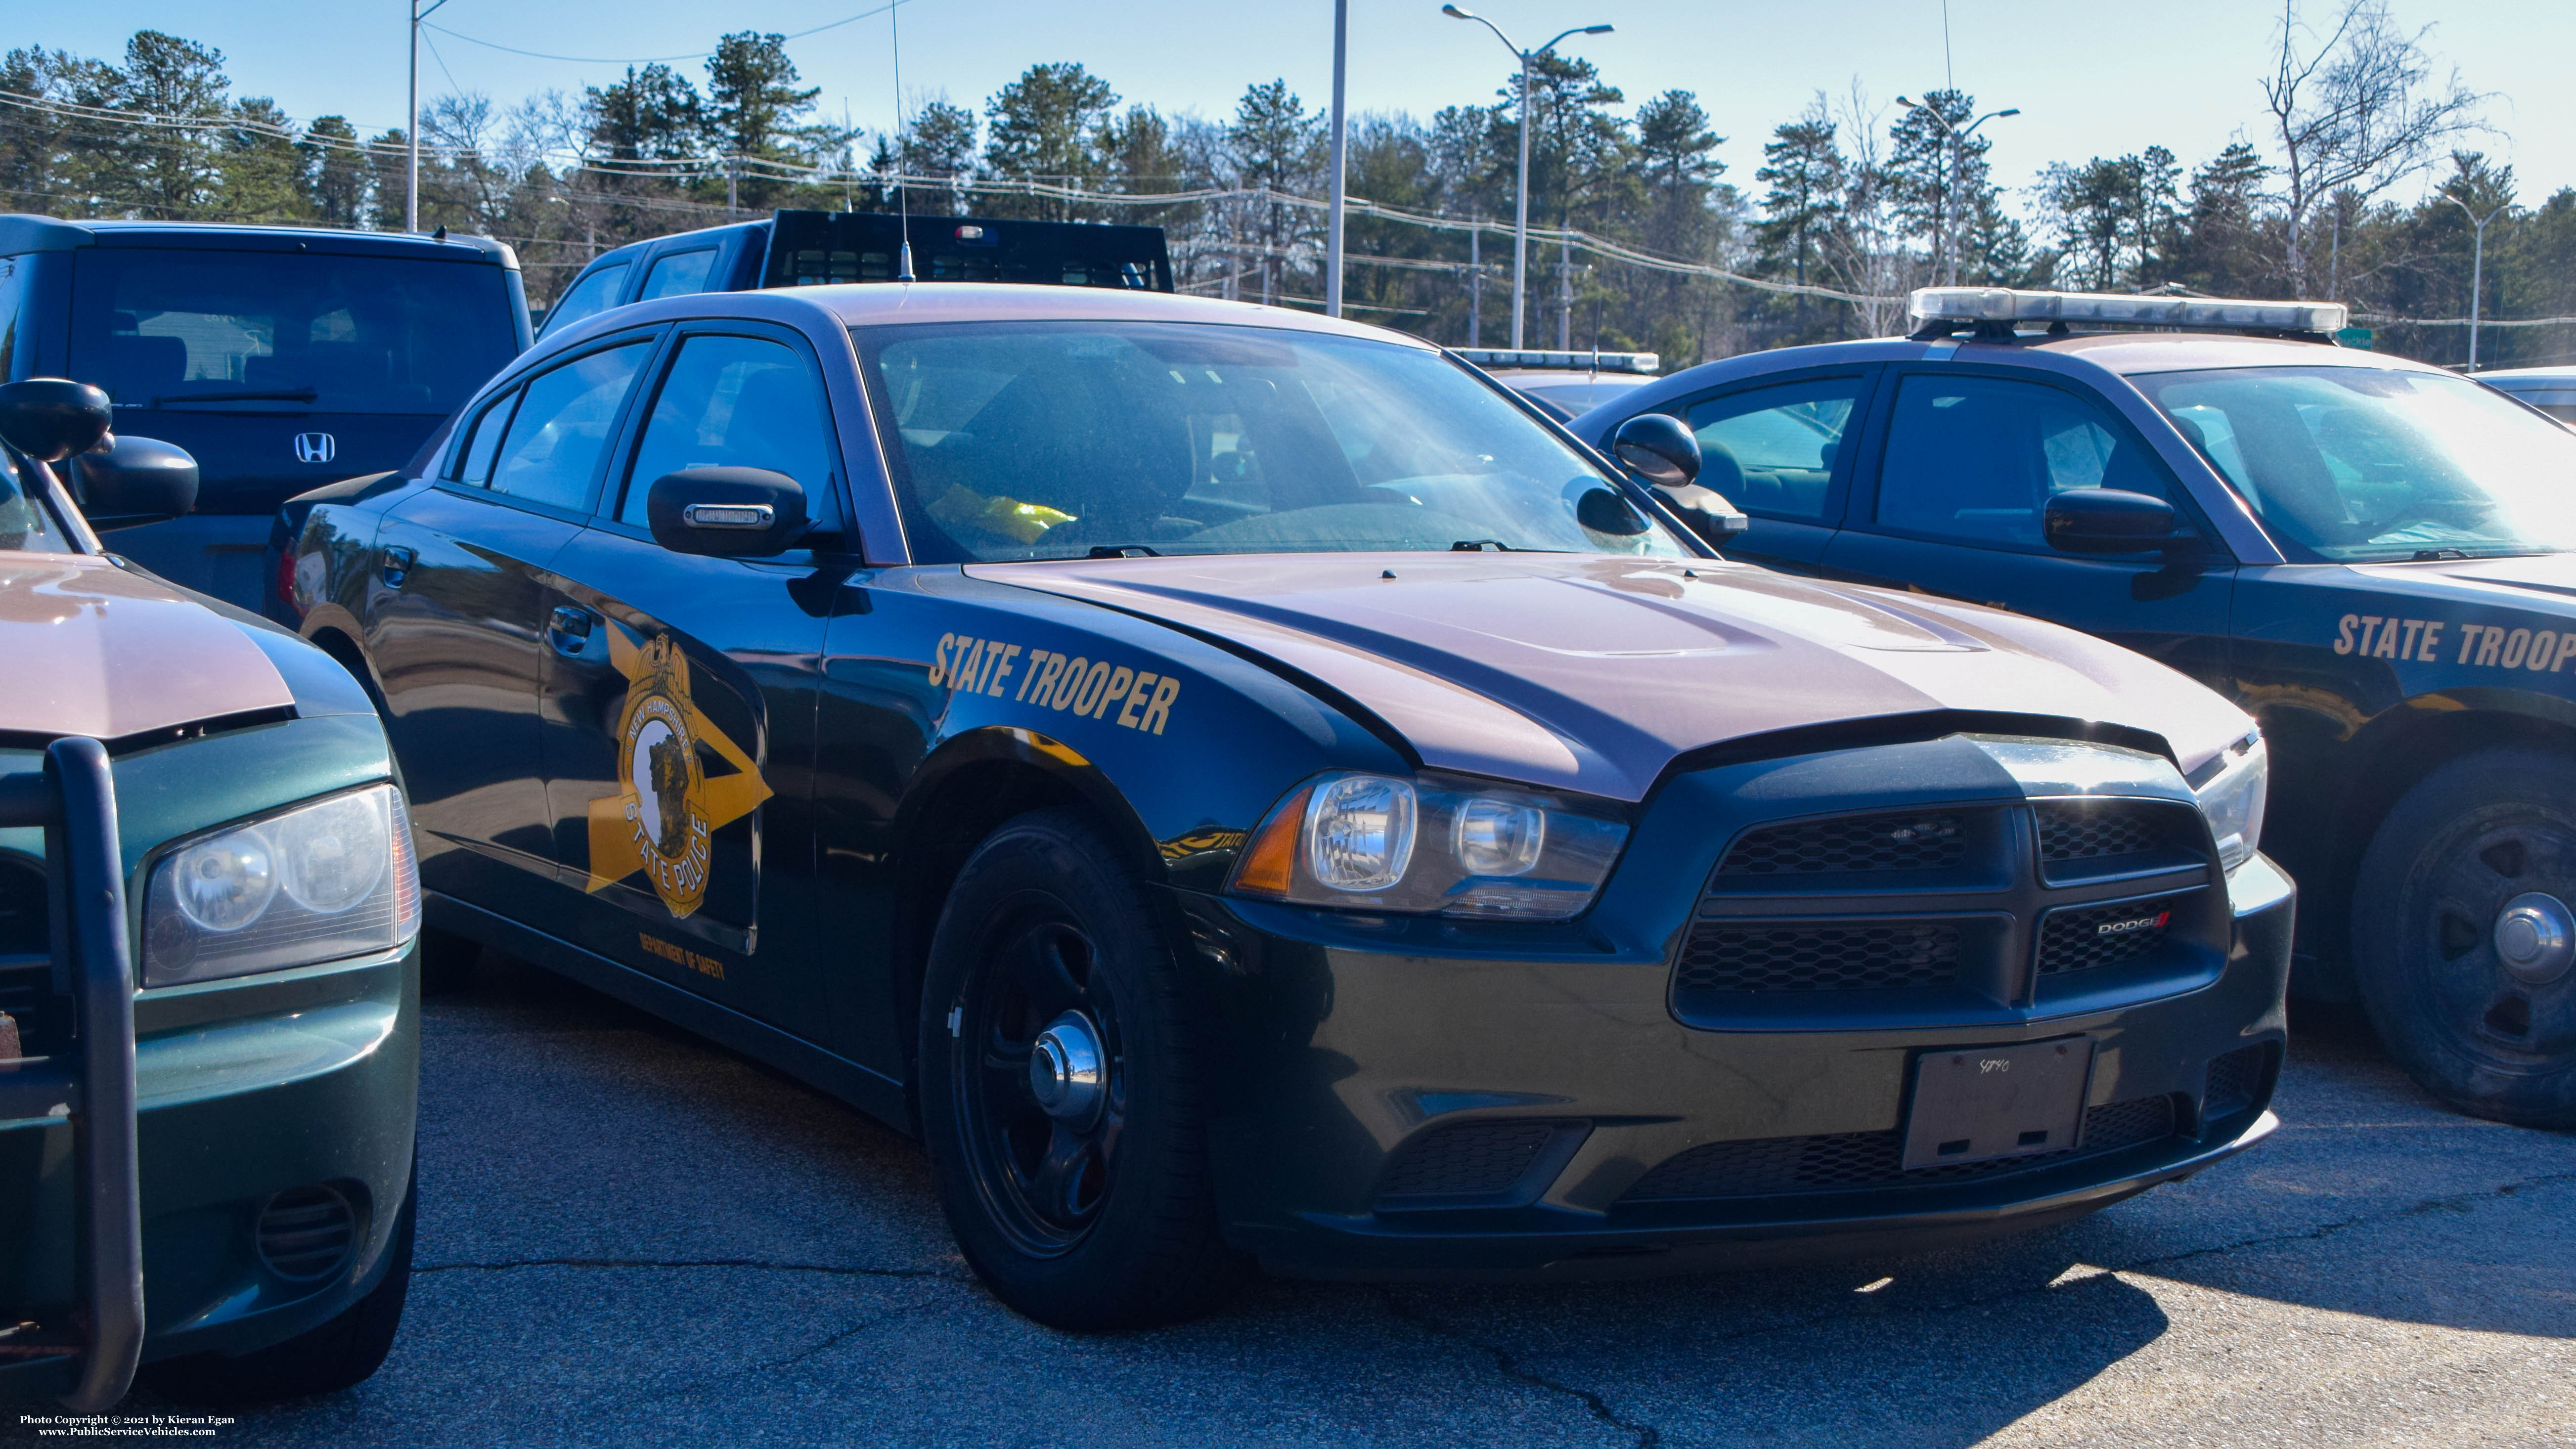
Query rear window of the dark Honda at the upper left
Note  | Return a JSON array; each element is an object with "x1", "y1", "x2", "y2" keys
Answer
[{"x1": 72, "y1": 247, "x2": 518, "y2": 417}]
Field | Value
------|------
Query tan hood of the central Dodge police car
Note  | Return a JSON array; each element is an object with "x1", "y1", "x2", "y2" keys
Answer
[{"x1": 966, "y1": 553, "x2": 2249, "y2": 800}]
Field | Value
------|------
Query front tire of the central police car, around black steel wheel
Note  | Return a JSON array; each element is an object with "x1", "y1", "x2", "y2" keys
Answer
[{"x1": 917, "y1": 811, "x2": 1239, "y2": 1331}]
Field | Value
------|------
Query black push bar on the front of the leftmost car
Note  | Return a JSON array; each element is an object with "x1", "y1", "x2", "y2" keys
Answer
[{"x1": 0, "y1": 739, "x2": 144, "y2": 1413}]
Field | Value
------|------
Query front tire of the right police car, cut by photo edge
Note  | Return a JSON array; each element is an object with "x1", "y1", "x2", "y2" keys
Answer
[{"x1": 2352, "y1": 749, "x2": 2576, "y2": 1127}]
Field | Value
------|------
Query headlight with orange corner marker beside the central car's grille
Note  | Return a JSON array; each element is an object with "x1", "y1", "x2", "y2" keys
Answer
[{"x1": 1231, "y1": 772, "x2": 1628, "y2": 922}]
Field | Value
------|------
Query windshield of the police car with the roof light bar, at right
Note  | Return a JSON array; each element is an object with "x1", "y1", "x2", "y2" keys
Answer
[{"x1": 2131, "y1": 368, "x2": 2576, "y2": 564}]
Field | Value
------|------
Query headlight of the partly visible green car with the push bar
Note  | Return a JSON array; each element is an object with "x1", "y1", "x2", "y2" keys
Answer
[{"x1": 144, "y1": 785, "x2": 420, "y2": 986}]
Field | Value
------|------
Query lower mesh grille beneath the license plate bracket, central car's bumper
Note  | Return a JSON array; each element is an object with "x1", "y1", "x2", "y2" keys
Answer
[{"x1": 1620, "y1": 1097, "x2": 2174, "y2": 1204}]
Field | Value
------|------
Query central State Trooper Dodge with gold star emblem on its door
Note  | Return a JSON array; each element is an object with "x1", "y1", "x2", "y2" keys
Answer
[{"x1": 296, "y1": 283, "x2": 2293, "y2": 1328}]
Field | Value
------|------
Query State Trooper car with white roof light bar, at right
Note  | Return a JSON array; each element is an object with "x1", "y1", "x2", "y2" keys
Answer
[{"x1": 1574, "y1": 288, "x2": 2576, "y2": 1127}]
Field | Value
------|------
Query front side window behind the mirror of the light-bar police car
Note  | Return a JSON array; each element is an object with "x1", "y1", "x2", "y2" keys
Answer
[{"x1": 1878, "y1": 373, "x2": 2174, "y2": 551}]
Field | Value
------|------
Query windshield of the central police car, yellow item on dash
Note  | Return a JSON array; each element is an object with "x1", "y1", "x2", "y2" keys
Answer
[{"x1": 853, "y1": 322, "x2": 1685, "y2": 564}]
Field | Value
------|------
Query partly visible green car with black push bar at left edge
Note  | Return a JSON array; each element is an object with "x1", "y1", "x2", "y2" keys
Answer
[{"x1": 0, "y1": 381, "x2": 420, "y2": 1413}]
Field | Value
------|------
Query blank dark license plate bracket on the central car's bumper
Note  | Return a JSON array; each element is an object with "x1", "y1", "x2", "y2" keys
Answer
[{"x1": 1904, "y1": 1037, "x2": 2094, "y2": 1171}]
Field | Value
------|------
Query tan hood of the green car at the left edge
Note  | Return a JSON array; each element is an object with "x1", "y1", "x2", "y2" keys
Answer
[{"x1": 0, "y1": 553, "x2": 296, "y2": 739}]
